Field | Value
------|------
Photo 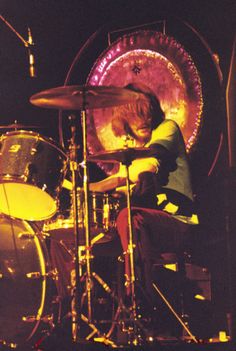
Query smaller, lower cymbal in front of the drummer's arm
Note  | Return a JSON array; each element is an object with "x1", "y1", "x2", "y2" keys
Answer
[{"x1": 88, "y1": 147, "x2": 151, "y2": 164}]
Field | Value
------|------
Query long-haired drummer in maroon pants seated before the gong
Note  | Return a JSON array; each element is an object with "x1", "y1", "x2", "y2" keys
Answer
[{"x1": 89, "y1": 84, "x2": 198, "y2": 303}]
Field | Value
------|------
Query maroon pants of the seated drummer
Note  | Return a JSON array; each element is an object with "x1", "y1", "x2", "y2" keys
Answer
[{"x1": 117, "y1": 207, "x2": 189, "y2": 295}]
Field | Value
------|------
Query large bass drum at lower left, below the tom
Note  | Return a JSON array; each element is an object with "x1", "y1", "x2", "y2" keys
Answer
[{"x1": 0, "y1": 215, "x2": 53, "y2": 348}]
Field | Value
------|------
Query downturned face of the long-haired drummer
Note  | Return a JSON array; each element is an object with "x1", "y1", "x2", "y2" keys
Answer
[{"x1": 129, "y1": 115, "x2": 152, "y2": 143}]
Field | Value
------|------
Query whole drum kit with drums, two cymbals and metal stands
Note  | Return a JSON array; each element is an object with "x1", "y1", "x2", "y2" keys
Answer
[{"x1": 0, "y1": 86, "x2": 155, "y2": 348}]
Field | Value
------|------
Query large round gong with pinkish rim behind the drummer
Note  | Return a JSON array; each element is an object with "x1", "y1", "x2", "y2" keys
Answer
[{"x1": 87, "y1": 30, "x2": 203, "y2": 172}]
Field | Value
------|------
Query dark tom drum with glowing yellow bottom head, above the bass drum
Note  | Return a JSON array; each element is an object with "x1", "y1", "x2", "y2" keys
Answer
[{"x1": 0, "y1": 130, "x2": 67, "y2": 221}]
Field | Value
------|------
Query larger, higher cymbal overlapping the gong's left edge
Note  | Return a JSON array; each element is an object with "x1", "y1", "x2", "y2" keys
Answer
[{"x1": 30, "y1": 85, "x2": 144, "y2": 110}]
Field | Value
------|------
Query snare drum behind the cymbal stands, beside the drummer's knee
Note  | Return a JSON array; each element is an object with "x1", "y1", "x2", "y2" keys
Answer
[{"x1": 43, "y1": 189, "x2": 120, "y2": 245}]
